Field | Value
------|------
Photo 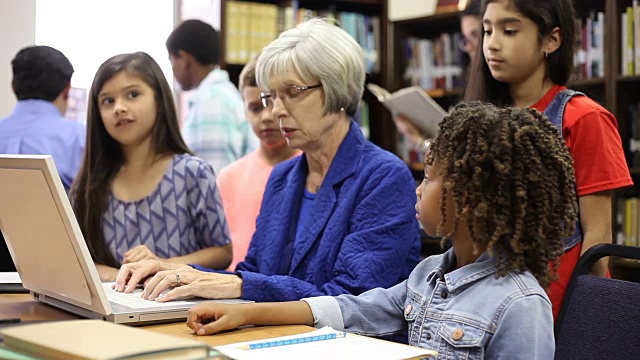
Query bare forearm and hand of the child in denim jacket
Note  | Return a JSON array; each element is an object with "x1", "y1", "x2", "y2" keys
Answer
[{"x1": 187, "y1": 301, "x2": 313, "y2": 335}]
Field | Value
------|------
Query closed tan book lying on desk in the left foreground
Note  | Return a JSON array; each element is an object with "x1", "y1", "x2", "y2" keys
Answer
[{"x1": 0, "y1": 320, "x2": 209, "y2": 360}]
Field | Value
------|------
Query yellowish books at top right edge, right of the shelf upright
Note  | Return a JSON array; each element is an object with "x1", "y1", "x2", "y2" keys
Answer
[{"x1": 620, "y1": 0, "x2": 640, "y2": 76}]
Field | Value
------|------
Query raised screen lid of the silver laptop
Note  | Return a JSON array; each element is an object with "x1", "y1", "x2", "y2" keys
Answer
[{"x1": 0, "y1": 155, "x2": 108, "y2": 312}]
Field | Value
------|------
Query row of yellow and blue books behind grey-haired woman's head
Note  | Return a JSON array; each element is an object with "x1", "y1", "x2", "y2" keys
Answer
[{"x1": 225, "y1": 0, "x2": 380, "y2": 72}]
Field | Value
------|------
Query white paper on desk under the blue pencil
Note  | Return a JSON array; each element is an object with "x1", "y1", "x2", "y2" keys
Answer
[{"x1": 215, "y1": 327, "x2": 437, "y2": 360}]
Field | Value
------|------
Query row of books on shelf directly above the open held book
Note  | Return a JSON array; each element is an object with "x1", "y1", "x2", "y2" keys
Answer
[{"x1": 402, "y1": 32, "x2": 465, "y2": 90}]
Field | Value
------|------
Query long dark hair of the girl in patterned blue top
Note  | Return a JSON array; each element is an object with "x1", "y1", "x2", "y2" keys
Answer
[{"x1": 71, "y1": 52, "x2": 191, "y2": 267}]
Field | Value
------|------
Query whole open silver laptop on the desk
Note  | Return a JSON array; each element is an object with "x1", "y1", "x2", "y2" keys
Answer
[{"x1": 0, "y1": 154, "x2": 247, "y2": 325}]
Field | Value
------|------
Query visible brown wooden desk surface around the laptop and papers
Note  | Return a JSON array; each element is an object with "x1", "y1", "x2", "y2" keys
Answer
[{"x1": 0, "y1": 294, "x2": 314, "y2": 346}]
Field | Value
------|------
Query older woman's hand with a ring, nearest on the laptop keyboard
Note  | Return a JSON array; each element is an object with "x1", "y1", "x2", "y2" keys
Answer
[{"x1": 142, "y1": 266, "x2": 242, "y2": 302}]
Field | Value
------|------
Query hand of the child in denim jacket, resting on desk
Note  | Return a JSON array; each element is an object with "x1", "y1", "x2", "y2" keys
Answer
[{"x1": 187, "y1": 303, "x2": 246, "y2": 335}]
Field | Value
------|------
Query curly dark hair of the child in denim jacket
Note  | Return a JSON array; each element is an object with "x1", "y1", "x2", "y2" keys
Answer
[{"x1": 425, "y1": 101, "x2": 578, "y2": 288}]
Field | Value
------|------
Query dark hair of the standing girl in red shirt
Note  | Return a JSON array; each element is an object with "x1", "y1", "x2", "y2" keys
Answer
[{"x1": 464, "y1": 0, "x2": 576, "y2": 105}]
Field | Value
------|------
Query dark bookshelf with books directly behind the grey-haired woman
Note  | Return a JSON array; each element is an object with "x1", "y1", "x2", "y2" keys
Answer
[{"x1": 215, "y1": 0, "x2": 395, "y2": 150}]
